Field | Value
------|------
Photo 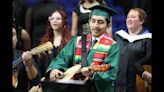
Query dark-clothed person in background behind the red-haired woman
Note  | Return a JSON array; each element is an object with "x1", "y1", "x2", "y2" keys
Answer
[{"x1": 25, "y1": 0, "x2": 64, "y2": 48}]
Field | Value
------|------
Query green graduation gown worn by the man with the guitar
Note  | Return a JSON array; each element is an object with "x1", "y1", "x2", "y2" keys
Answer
[{"x1": 47, "y1": 37, "x2": 119, "y2": 92}]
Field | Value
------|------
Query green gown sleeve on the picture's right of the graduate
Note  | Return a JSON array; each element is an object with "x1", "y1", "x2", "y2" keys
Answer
[{"x1": 93, "y1": 43, "x2": 119, "y2": 92}]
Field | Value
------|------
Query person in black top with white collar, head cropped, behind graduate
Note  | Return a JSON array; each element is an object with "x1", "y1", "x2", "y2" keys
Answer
[{"x1": 72, "y1": 0, "x2": 105, "y2": 36}]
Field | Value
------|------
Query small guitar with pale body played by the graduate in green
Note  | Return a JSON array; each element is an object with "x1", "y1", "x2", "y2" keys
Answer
[{"x1": 60, "y1": 64, "x2": 111, "y2": 80}]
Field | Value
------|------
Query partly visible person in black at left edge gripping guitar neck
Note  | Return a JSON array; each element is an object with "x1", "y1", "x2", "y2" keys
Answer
[{"x1": 12, "y1": 25, "x2": 41, "y2": 92}]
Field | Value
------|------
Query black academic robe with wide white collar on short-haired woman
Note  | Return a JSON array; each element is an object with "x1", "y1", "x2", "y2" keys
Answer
[{"x1": 114, "y1": 30, "x2": 152, "y2": 92}]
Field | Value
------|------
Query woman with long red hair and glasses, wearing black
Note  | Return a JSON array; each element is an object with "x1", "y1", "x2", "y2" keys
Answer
[{"x1": 35, "y1": 9, "x2": 72, "y2": 77}]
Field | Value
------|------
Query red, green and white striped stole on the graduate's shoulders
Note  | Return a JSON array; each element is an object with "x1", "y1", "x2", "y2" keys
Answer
[{"x1": 75, "y1": 34, "x2": 113, "y2": 65}]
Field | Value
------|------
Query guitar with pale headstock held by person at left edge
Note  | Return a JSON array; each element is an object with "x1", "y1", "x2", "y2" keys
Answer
[{"x1": 12, "y1": 41, "x2": 53, "y2": 88}]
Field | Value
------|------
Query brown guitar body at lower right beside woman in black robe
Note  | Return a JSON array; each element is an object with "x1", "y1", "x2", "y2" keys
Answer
[{"x1": 136, "y1": 65, "x2": 152, "y2": 92}]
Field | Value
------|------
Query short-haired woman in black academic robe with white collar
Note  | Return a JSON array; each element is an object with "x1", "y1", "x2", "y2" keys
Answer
[{"x1": 114, "y1": 8, "x2": 152, "y2": 92}]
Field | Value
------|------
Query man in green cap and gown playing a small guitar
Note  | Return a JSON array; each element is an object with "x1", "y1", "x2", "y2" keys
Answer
[{"x1": 47, "y1": 5, "x2": 119, "y2": 92}]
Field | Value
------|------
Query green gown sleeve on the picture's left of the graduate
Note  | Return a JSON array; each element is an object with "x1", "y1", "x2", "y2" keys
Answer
[{"x1": 46, "y1": 38, "x2": 76, "y2": 72}]
